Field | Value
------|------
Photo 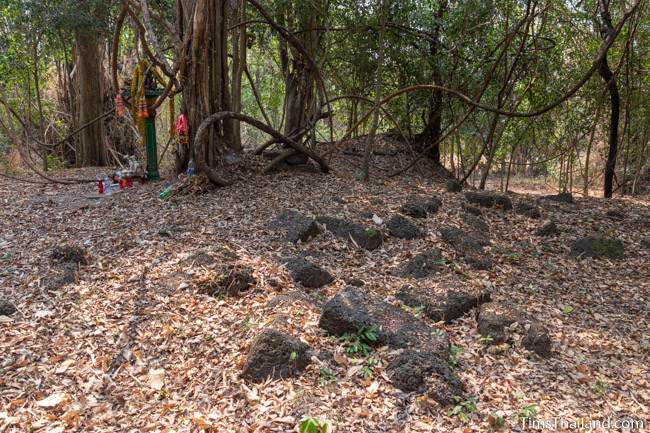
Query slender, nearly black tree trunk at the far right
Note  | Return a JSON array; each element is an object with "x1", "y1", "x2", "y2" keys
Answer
[{"x1": 598, "y1": 0, "x2": 621, "y2": 198}]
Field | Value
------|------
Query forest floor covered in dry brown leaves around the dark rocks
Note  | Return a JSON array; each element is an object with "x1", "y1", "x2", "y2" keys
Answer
[{"x1": 0, "y1": 146, "x2": 650, "y2": 433}]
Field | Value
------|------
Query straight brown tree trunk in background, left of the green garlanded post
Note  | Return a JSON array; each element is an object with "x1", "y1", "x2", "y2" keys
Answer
[{"x1": 75, "y1": 31, "x2": 107, "y2": 167}]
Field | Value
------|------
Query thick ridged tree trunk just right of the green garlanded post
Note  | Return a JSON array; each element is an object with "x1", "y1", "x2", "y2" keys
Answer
[{"x1": 177, "y1": 0, "x2": 236, "y2": 171}]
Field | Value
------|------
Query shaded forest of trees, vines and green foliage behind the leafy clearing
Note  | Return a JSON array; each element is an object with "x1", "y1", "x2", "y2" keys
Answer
[{"x1": 0, "y1": 0, "x2": 650, "y2": 196}]
